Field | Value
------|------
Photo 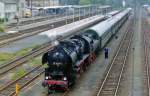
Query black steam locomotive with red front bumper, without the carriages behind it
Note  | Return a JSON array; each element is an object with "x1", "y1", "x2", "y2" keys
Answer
[{"x1": 42, "y1": 32, "x2": 99, "y2": 90}]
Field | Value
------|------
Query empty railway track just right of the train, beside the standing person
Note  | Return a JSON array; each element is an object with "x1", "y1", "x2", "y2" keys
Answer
[{"x1": 94, "y1": 17, "x2": 133, "y2": 96}]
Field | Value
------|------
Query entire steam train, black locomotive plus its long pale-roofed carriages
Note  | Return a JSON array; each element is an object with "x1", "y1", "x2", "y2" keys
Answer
[{"x1": 42, "y1": 8, "x2": 131, "y2": 91}]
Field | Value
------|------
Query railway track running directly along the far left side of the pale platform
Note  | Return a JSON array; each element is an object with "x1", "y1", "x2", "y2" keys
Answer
[{"x1": 0, "y1": 11, "x2": 99, "y2": 47}]
